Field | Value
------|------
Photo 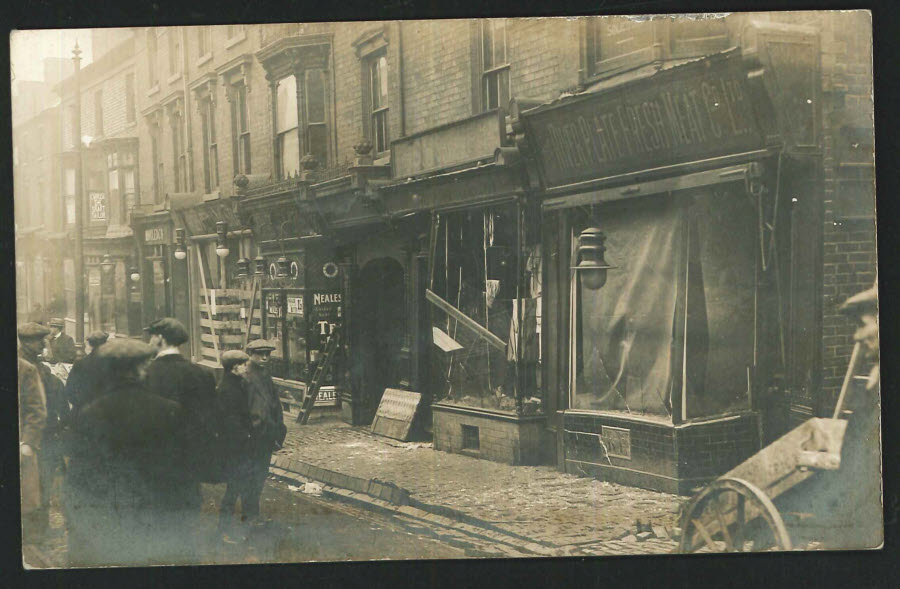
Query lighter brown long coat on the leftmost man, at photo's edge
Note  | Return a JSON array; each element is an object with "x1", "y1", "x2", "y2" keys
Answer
[{"x1": 18, "y1": 358, "x2": 47, "y2": 544}]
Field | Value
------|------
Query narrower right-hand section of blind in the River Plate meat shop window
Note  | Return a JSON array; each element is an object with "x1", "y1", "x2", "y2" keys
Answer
[{"x1": 685, "y1": 191, "x2": 758, "y2": 418}]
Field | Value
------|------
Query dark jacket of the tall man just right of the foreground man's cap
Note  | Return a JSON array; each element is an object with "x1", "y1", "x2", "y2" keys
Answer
[{"x1": 145, "y1": 354, "x2": 220, "y2": 482}]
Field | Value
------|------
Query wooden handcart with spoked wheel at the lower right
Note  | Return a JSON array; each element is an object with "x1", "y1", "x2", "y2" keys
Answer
[{"x1": 676, "y1": 343, "x2": 862, "y2": 553}]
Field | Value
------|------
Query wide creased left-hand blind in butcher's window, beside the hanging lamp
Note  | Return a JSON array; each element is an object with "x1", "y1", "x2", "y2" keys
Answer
[{"x1": 573, "y1": 199, "x2": 686, "y2": 416}]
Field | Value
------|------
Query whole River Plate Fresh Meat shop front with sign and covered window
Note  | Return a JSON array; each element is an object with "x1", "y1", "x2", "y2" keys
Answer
[{"x1": 514, "y1": 29, "x2": 821, "y2": 493}]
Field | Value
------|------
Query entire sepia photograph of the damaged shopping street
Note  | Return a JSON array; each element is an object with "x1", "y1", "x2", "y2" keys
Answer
[{"x1": 6, "y1": 11, "x2": 887, "y2": 569}]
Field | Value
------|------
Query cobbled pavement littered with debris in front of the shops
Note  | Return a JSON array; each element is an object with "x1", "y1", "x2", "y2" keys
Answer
[{"x1": 274, "y1": 415, "x2": 681, "y2": 554}]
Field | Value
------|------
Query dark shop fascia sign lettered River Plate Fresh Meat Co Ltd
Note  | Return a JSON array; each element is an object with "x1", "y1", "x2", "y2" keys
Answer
[{"x1": 522, "y1": 54, "x2": 766, "y2": 189}]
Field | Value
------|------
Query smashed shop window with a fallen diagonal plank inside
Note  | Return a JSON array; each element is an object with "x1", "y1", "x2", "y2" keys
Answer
[{"x1": 427, "y1": 205, "x2": 540, "y2": 412}]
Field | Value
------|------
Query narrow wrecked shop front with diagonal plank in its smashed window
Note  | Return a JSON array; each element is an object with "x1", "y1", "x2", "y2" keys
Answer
[{"x1": 379, "y1": 110, "x2": 553, "y2": 464}]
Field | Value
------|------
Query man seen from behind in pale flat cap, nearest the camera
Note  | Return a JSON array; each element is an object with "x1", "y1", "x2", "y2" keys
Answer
[{"x1": 65, "y1": 338, "x2": 186, "y2": 566}]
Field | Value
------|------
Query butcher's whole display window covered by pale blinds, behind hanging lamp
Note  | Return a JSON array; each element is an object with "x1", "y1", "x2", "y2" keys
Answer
[{"x1": 570, "y1": 191, "x2": 758, "y2": 419}]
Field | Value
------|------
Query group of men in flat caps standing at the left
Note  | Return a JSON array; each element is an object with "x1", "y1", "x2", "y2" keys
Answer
[{"x1": 18, "y1": 318, "x2": 287, "y2": 566}]
